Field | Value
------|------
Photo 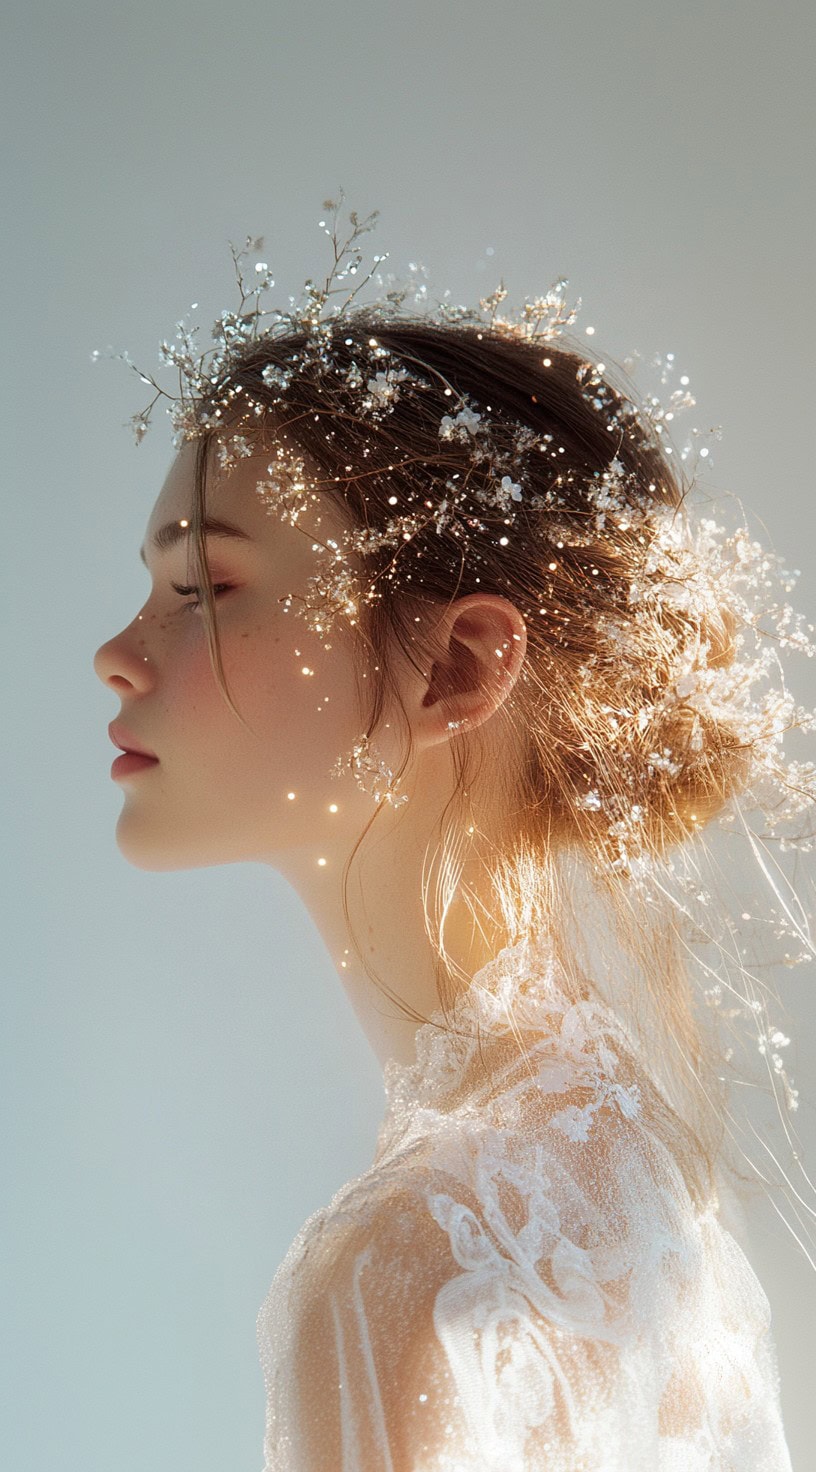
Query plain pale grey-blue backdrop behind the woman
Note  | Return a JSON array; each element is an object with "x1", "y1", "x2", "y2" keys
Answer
[{"x1": 0, "y1": 0, "x2": 816, "y2": 1472}]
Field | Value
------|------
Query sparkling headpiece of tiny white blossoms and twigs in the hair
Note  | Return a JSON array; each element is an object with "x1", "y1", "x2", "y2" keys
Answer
[{"x1": 91, "y1": 194, "x2": 816, "y2": 1260}]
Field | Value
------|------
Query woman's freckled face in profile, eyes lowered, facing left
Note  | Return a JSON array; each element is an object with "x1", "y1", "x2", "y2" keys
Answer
[{"x1": 94, "y1": 442, "x2": 373, "y2": 870}]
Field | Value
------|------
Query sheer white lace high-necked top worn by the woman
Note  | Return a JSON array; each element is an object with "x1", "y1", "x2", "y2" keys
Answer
[{"x1": 258, "y1": 942, "x2": 791, "y2": 1472}]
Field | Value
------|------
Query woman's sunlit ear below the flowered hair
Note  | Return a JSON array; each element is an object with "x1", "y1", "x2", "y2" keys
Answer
[{"x1": 411, "y1": 593, "x2": 527, "y2": 746}]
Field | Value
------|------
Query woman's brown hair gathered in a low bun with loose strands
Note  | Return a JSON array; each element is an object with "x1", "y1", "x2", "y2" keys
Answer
[{"x1": 181, "y1": 308, "x2": 771, "y2": 1201}]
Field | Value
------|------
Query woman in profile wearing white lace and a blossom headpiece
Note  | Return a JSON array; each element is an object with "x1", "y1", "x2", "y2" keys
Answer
[{"x1": 96, "y1": 204, "x2": 813, "y2": 1472}]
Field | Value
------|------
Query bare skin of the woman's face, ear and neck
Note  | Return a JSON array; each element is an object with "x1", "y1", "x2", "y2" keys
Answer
[{"x1": 94, "y1": 443, "x2": 526, "y2": 1063}]
